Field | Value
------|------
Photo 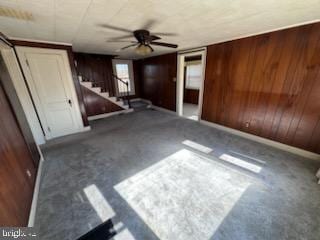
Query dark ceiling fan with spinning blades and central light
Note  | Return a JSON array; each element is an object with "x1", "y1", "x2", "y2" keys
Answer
[{"x1": 100, "y1": 21, "x2": 178, "y2": 55}]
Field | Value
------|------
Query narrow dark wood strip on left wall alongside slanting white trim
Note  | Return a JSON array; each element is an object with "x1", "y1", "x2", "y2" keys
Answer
[{"x1": 0, "y1": 55, "x2": 40, "y2": 166}]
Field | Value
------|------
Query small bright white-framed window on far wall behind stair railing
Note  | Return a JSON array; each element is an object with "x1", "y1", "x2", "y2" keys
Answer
[{"x1": 112, "y1": 59, "x2": 134, "y2": 95}]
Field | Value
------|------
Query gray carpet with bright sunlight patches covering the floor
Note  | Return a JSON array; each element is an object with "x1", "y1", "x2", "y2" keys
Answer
[{"x1": 36, "y1": 107, "x2": 320, "y2": 240}]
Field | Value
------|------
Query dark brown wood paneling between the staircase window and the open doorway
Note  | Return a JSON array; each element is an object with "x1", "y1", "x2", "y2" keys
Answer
[{"x1": 141, "y1": 53, "x2": 177, "y2": 111}]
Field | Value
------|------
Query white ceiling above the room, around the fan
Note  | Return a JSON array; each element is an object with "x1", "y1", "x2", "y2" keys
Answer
[{"x1": 0, "y1": 0, "x2": 320, "y2": 58}]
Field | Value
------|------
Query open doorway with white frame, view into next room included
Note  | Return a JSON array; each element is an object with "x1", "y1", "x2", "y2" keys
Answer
[{"x1": 177, "y1": 49, "x2": 206, "y2": 121}]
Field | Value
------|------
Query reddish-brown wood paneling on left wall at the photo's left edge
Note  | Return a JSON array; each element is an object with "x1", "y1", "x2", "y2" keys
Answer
[{"x1": 0, "y1": 83, "x2": 36, "y2": 226}]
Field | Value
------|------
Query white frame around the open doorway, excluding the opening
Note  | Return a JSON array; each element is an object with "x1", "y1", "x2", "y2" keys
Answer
[{"x1": 176, "y1": 47, "x2": 207, "y2": 121}]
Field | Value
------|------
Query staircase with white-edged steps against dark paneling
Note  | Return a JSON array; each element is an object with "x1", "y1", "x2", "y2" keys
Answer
[{"x1": 78, "y1": 76, "x2": 130, "y2": 109}]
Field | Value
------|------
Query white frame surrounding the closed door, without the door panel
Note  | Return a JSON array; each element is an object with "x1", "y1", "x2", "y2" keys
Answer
[{"x1": 15, "y1": 46, "x2": 84, "y2": 140}]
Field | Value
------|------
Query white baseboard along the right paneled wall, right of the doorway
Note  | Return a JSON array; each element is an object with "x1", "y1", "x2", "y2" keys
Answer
[{"x1": 200, "y1": 120, "x2": 320, "y2": 160}]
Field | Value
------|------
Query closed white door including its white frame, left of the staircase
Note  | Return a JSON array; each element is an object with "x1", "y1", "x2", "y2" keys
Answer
[{"x1": 17, "y1": 47, "x2": 83, "y2": 139}]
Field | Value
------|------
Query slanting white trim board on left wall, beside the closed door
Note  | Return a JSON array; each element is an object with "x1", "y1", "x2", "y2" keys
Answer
[{"x1": 1, "y1": 48, "x2": 46, "y2": 145}]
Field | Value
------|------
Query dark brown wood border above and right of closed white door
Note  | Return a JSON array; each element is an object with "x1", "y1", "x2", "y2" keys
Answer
[{"x1": 10, "y1": 40, "x2": 89, "y2": 126}]
